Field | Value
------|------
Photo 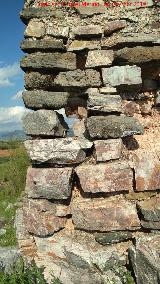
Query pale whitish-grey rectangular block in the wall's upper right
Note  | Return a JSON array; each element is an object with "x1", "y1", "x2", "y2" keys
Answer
[{"x1": 102, "y1": 65, "x2": 142, "y2": 89}]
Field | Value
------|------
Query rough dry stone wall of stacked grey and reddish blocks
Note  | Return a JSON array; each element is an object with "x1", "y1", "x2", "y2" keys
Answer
[{"x1": 16, "y1": 0, "x2": 160, "y2": 284}]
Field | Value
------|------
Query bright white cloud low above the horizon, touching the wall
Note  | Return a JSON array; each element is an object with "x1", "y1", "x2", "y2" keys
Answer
[{"x1": 0, "y1": 106, "x2": 28, "y2": 124}]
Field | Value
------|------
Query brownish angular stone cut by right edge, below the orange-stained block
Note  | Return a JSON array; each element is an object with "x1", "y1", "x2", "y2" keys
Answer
[{"x1": 138, "y1": 194, "x2": 160, "y2": 222}]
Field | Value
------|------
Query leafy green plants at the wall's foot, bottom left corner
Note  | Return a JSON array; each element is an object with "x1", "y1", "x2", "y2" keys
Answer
[{"x1": 0, "y1": 261, "x2": 61, "y2": 284}]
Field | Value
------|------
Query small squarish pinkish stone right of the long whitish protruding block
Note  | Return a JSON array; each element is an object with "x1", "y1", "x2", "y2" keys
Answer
[{"x1": 94, "y1": 139, "x2": 123, "y2": 162}]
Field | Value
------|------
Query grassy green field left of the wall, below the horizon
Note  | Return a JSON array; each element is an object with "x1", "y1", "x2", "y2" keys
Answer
[{"x1": 0, "y1": 141, "x2": 29, "y2": 246}]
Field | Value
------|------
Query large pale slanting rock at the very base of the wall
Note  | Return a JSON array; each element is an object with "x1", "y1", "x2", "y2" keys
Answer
[{"x1": 35, "y1": 231, "x2": 129, "y2": 284}]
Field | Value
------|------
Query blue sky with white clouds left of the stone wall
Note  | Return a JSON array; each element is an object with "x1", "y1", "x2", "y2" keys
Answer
[{"x1": 0, "y1": 0, "x2": 25, "y2": 132}]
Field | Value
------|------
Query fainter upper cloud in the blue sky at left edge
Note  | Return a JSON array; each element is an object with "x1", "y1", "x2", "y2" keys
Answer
[{"x1": 0, "y1": 62, "x2": 21, "y2": 87}]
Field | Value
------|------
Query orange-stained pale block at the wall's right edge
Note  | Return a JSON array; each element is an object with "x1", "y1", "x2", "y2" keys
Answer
[{"x1": 134, "y1": 152, "x2": 160, "y2": 191}]
